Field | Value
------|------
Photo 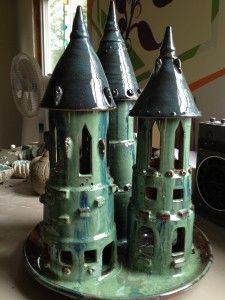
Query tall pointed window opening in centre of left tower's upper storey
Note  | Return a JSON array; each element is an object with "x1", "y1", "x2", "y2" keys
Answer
[{"x1": 80, "y1": 125, "x2": 92, "y2": 175}]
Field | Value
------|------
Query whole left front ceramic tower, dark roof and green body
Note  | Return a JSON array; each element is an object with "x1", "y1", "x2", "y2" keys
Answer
[{"x1": 25, "y1": 7, "x2": 116, "y2": 285}]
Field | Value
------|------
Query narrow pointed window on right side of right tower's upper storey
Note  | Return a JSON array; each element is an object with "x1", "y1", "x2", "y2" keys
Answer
[{"x1": 175, "y1": 122, "x2": 184, "y2": 170}]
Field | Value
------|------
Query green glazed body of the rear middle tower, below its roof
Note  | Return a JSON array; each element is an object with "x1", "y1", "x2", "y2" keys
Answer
[{"x1": 109, "y1": 101, "x2": 136, "y2": 239}]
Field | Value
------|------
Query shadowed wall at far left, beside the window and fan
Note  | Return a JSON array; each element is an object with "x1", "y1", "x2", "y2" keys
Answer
[{"x1": 0, "y1": 0, "x2": 34, "y2": 148}]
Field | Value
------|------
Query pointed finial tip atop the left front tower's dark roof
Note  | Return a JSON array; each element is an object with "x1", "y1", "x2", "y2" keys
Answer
[{"x1": 70, "y1": 5, "x2": 89, "y2": 39}]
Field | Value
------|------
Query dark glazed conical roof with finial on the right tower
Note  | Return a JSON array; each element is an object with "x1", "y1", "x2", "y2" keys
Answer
[{"x1": 130, "y1": 26, "x2": 201, "y2": 118}]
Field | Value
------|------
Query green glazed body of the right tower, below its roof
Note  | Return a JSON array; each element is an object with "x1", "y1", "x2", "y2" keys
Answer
[{"x1": 128, "y1": 118, "x2": 194, "y2": 275}]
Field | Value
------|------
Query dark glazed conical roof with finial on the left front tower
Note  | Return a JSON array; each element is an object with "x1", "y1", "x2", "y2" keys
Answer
[{"x1": 41, "y1": 6, "x2": 115, "y2": 111}]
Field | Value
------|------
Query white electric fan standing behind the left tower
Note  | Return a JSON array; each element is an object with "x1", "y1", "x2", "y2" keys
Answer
[{"x1": 11, "y1": 53, "x2": 49, "y2": 145}]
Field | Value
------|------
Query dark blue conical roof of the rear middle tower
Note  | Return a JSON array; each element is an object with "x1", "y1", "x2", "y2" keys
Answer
[{"x1": 98, "y1": 1, "x2": 140, "y2": 101}]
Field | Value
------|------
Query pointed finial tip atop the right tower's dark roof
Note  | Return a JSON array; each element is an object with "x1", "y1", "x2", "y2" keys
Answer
[{"x1": 159, "y1": 26, "x2": 176, "y2": 58}]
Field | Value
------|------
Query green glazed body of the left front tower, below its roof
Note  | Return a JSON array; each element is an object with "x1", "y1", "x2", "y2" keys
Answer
[{"x1": 40, "y1": 111, "x2": 117, "y2": 282}]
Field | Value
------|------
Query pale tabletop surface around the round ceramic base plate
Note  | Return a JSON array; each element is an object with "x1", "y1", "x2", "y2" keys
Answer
[{"x1": 0, "y1": 179, "x2": 225, "y2": 300}]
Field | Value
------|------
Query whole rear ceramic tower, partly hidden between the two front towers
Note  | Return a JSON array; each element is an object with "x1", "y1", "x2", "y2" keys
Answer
[{"x1": 98, "y1": 1, "x2": 140, "y2": 240}]
